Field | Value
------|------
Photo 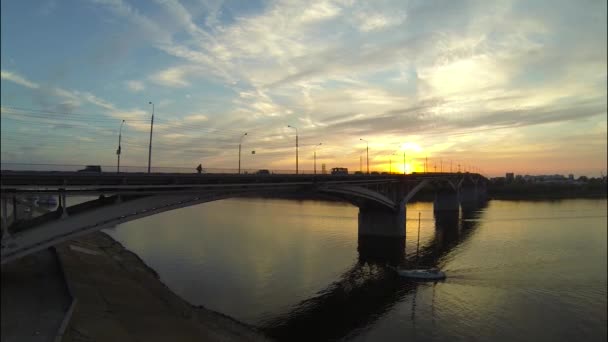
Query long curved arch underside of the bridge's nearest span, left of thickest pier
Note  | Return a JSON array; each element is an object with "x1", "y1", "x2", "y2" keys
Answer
[{"x1": 1, "y1": 185, "x2": 404, "y2": 264}]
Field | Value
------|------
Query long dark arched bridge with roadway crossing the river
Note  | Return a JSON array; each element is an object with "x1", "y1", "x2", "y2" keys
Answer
[{"x1": 0, "y1": 170, "x2": 487, "y2": 264}]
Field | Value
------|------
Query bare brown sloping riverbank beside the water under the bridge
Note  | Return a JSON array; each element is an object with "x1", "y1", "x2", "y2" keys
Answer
[{"x1": 57, "y1": 232, "x2": 269, "y2": 342}]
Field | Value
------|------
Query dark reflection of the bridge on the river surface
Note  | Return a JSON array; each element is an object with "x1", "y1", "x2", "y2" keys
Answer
[{"x1": 259, "y1": 202, "x2": 481, "y2": 341}]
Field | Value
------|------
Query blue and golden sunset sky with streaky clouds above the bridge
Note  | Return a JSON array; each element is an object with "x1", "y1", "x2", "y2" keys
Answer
[{"x1": 0, "y1": 0, "x2": 607, "y2": 176}]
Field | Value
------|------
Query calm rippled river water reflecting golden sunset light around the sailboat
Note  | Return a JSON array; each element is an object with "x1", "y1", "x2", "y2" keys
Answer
[{"x1": 108, "y1": 199, "x2": 608, "y2": 341}]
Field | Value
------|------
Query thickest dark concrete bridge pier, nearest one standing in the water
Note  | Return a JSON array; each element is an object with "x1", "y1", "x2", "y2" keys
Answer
[{"x1": 359, "y1": 206, "x2": 405, "y2": 237}]
